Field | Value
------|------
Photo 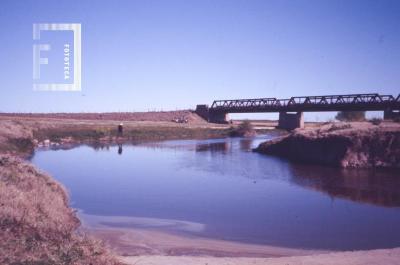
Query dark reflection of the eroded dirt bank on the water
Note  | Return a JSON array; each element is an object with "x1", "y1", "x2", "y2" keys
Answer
[{"x1": 290, "y1": 164, "x2": 400, "y2": 207}]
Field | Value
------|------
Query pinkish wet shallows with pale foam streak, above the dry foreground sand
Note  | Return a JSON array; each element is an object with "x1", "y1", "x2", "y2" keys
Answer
[{"x1": 79, "y1": 213, "x2": 327, "y2": 257}]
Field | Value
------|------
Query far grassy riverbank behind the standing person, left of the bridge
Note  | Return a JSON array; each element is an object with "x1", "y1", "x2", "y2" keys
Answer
[{"x1": 0, "y1": 114, "x2": 231, "y2": 158}]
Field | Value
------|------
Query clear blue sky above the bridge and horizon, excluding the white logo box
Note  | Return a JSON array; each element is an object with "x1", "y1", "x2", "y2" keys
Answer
[{"x1": 0, "y1": 0, "x2": 400, "y2": 118}]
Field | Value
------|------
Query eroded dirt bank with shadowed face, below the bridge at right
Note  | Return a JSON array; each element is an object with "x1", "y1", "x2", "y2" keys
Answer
[{"x1": 255, "y1": 122, "x2": 400, "y2": 168}]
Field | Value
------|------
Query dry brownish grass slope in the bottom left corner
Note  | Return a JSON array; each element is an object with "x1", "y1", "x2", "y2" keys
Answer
[{"x1": 0, "y1": 155, "x2": 123, "y2": 265}]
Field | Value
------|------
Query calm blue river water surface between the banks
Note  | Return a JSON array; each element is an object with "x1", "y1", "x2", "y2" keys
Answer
[{"x1": 33, "y1": 135, "x2": 400, "y2": 250}]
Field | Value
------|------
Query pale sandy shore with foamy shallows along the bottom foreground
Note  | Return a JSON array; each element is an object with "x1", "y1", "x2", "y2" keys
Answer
[{"x1": 80, "y1": 209, "x2": 400, "y2": 265}]
